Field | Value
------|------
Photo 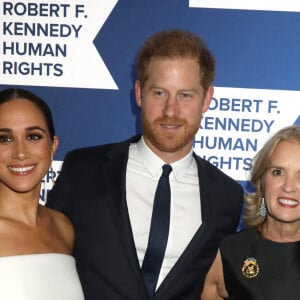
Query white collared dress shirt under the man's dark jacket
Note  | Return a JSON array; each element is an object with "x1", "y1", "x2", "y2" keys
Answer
[{"x1": 126, "y1": 137, "x2": 202, "y2": 287}]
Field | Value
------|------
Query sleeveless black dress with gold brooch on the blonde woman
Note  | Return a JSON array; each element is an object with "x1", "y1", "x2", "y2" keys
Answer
[{"x1": 220, "y1": 229, "x2": 300, "y2": 300}]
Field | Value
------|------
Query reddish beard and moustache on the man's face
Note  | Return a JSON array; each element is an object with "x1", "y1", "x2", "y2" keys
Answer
[{"x1": 142, "y1": 113, "x2": 200, "y2": 153}]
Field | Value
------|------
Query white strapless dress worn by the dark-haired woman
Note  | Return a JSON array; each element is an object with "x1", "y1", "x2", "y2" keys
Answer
[{"x1": 0, "y1": 253, "x2": 84, "y2": 300}]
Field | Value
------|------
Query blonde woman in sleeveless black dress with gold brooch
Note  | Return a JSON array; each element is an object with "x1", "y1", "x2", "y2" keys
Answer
[{"x1": 201, "y1": 125, "x2": 300, "y2": 300}]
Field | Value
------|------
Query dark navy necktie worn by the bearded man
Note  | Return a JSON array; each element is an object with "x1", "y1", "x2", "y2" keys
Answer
[{"x1": 142, "y1": 165, "x2": 172, "y2": 299}]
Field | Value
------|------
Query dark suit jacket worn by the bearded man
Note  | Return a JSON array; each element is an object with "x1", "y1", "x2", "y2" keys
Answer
[{"x1": 47, "y1": 136, "x2": 243, "y2": 300}]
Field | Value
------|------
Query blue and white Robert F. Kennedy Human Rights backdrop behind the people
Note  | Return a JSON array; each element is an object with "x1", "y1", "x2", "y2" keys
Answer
[{"x1": 0, "y1": 0, "x2": 300, "y2": 202}]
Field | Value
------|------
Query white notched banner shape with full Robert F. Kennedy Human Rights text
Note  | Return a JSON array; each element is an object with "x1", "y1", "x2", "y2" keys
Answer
[{"x1": 0, "y1": 0, "x2": 118, "y2": 89}]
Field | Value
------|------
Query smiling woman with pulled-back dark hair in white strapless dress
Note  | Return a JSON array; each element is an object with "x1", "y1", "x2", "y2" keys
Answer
[{"x1": 0, "y1": 89, "x2": 84, "y2": 300}]
